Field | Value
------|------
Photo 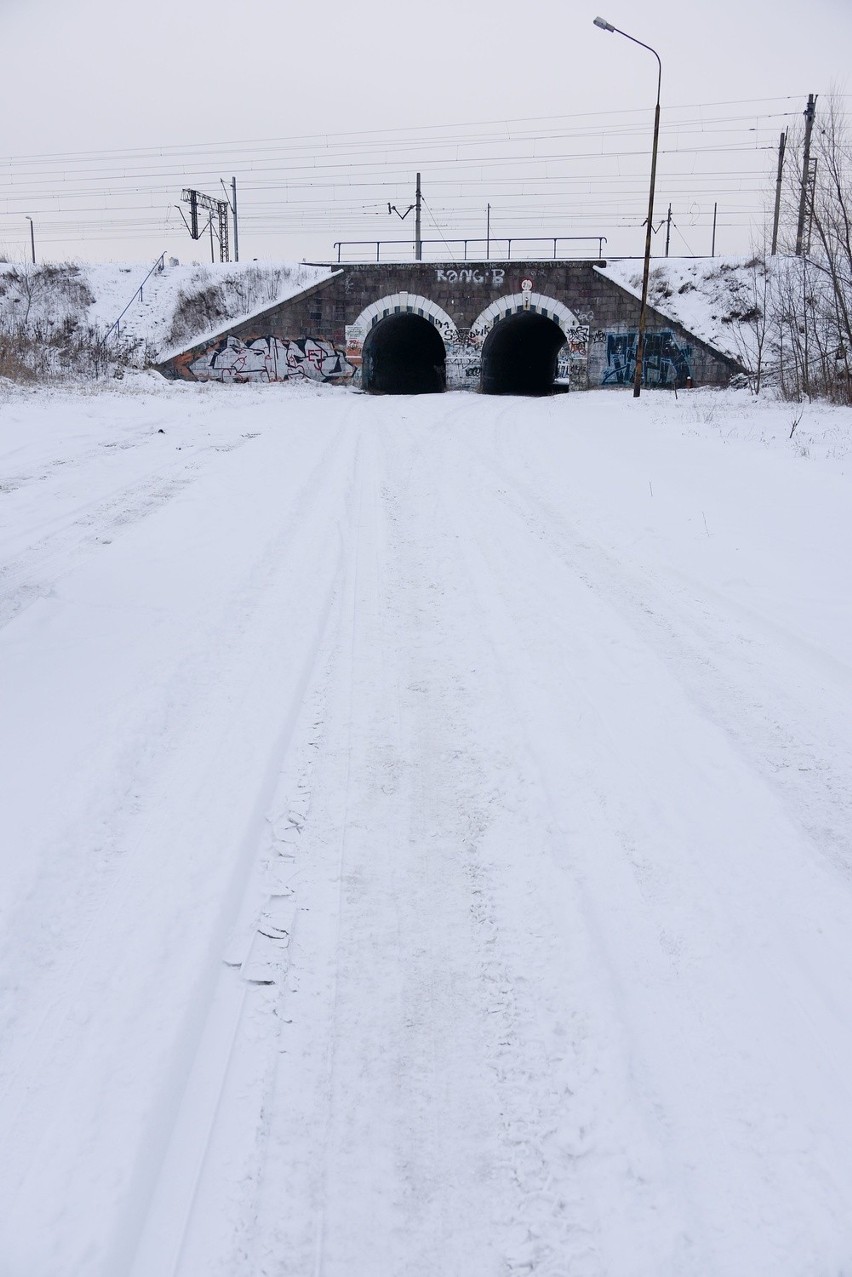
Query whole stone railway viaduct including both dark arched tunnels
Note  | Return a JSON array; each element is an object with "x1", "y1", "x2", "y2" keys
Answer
[{"x1": 158, "y1": 261, "x2": 740, "y2": 395}]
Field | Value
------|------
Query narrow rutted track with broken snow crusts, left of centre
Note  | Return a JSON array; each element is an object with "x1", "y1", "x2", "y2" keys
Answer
[{"x1": 130, "y1": 592, "x2": 342, "y2": 1277}]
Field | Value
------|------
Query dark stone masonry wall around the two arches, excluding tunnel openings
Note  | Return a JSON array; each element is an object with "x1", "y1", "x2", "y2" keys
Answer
[{"x1": 161, "y1": 261, "x2": 740, "y2": 388}]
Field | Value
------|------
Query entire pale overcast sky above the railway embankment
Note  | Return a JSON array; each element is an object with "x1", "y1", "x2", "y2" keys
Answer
[{"x1": 0, "y1": 0, "x2": 852, "y2": 261}]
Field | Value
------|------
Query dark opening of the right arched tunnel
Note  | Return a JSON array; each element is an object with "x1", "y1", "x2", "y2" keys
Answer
[{"x1": 479, "y1": 310, "x2": 565, "y2": 395}]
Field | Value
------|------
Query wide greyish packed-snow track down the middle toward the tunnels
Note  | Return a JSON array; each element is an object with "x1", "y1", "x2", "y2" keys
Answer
[{"x1": 247, "y1": 405, "x2": 533, "y2": 1277}]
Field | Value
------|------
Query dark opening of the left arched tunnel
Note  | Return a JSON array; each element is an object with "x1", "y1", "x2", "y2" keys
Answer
[{"x1": 361, "y1": 313, "x2": 447, "y2": 395}]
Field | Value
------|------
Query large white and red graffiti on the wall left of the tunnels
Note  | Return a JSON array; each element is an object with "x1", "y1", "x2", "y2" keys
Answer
[{"x1": 188, "y1": 336, "x2": 355, "y2": 382}]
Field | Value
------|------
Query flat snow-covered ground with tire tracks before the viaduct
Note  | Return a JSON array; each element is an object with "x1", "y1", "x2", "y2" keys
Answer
[{"x1": 0, "y1": 378, "x2": 852, "y2": 1277}]
